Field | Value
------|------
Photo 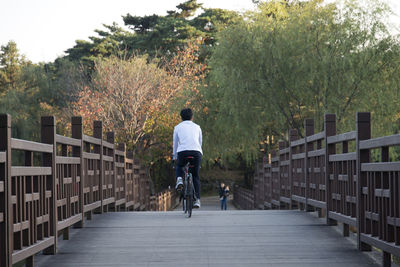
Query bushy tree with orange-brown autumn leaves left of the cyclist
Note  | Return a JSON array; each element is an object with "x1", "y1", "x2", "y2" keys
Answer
[{"x1": 73, "y1": 40, "x2": 205, "y2": 156}]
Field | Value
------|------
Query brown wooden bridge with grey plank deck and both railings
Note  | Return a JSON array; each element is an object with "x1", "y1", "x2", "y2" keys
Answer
[{"x1": 0, "y1": 113, "x2": 400, "y2": 267}]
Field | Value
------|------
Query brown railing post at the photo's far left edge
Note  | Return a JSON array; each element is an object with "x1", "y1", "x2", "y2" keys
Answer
[{"x1": 0, "y1": 114, "x2": 14, "y2": 267}]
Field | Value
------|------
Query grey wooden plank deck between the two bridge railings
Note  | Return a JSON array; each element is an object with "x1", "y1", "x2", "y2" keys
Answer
[{"x1": 35, "y1": 210, "x2": 379, "y2": 267}]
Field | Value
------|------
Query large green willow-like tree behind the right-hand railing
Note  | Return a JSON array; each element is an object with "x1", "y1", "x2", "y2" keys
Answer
[{"x1": 204, "y1": 0, "x2": 400, "y2": 163}]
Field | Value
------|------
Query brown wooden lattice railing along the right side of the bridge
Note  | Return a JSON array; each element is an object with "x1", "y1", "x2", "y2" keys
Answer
[{"x1": 234, "y1": 113, "x2": 400, "y2": 267}]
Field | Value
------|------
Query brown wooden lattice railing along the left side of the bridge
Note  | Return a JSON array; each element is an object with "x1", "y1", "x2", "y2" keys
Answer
[{"x1": 0, "y1": 115, "x2": 154, "y2": 267}]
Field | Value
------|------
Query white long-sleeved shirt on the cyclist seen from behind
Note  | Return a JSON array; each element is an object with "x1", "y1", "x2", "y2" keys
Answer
[{"x1": 172, "y1": 121, "x2": 203, "y2": 159}]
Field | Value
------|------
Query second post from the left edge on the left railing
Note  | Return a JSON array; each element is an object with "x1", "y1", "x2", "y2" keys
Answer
[{"x1": 40, "y1": 116, "x2": 58, "y2": 254}]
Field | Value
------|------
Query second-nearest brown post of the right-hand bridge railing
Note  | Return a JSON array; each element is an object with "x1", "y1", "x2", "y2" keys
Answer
[{"x1": 324, "y1": 114, "x2": 337, "y2": 225}]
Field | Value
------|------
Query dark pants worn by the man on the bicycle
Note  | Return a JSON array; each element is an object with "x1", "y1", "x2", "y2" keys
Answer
[{"x1": 176, "y1": 150, "x2": 201, "y2": 199}]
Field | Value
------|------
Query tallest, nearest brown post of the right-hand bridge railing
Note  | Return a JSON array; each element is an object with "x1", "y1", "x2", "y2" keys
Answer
[{"x1": 356, "y1": 112, "x2": 371, "y2": 251}]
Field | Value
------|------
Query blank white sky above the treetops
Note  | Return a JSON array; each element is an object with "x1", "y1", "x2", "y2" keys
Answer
[{"x1": 0, "y1": 0, "x2": 400, "y2": 63}]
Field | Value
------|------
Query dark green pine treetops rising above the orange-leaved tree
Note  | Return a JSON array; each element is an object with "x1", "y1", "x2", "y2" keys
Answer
[{"x1": 66, "y1": 0, "x2": 240, "y2": 64}]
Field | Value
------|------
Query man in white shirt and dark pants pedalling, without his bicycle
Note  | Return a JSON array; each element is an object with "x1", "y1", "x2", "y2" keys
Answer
[{"x1": 172, "y1": 108, "x2": 203, "y2": 208}]
